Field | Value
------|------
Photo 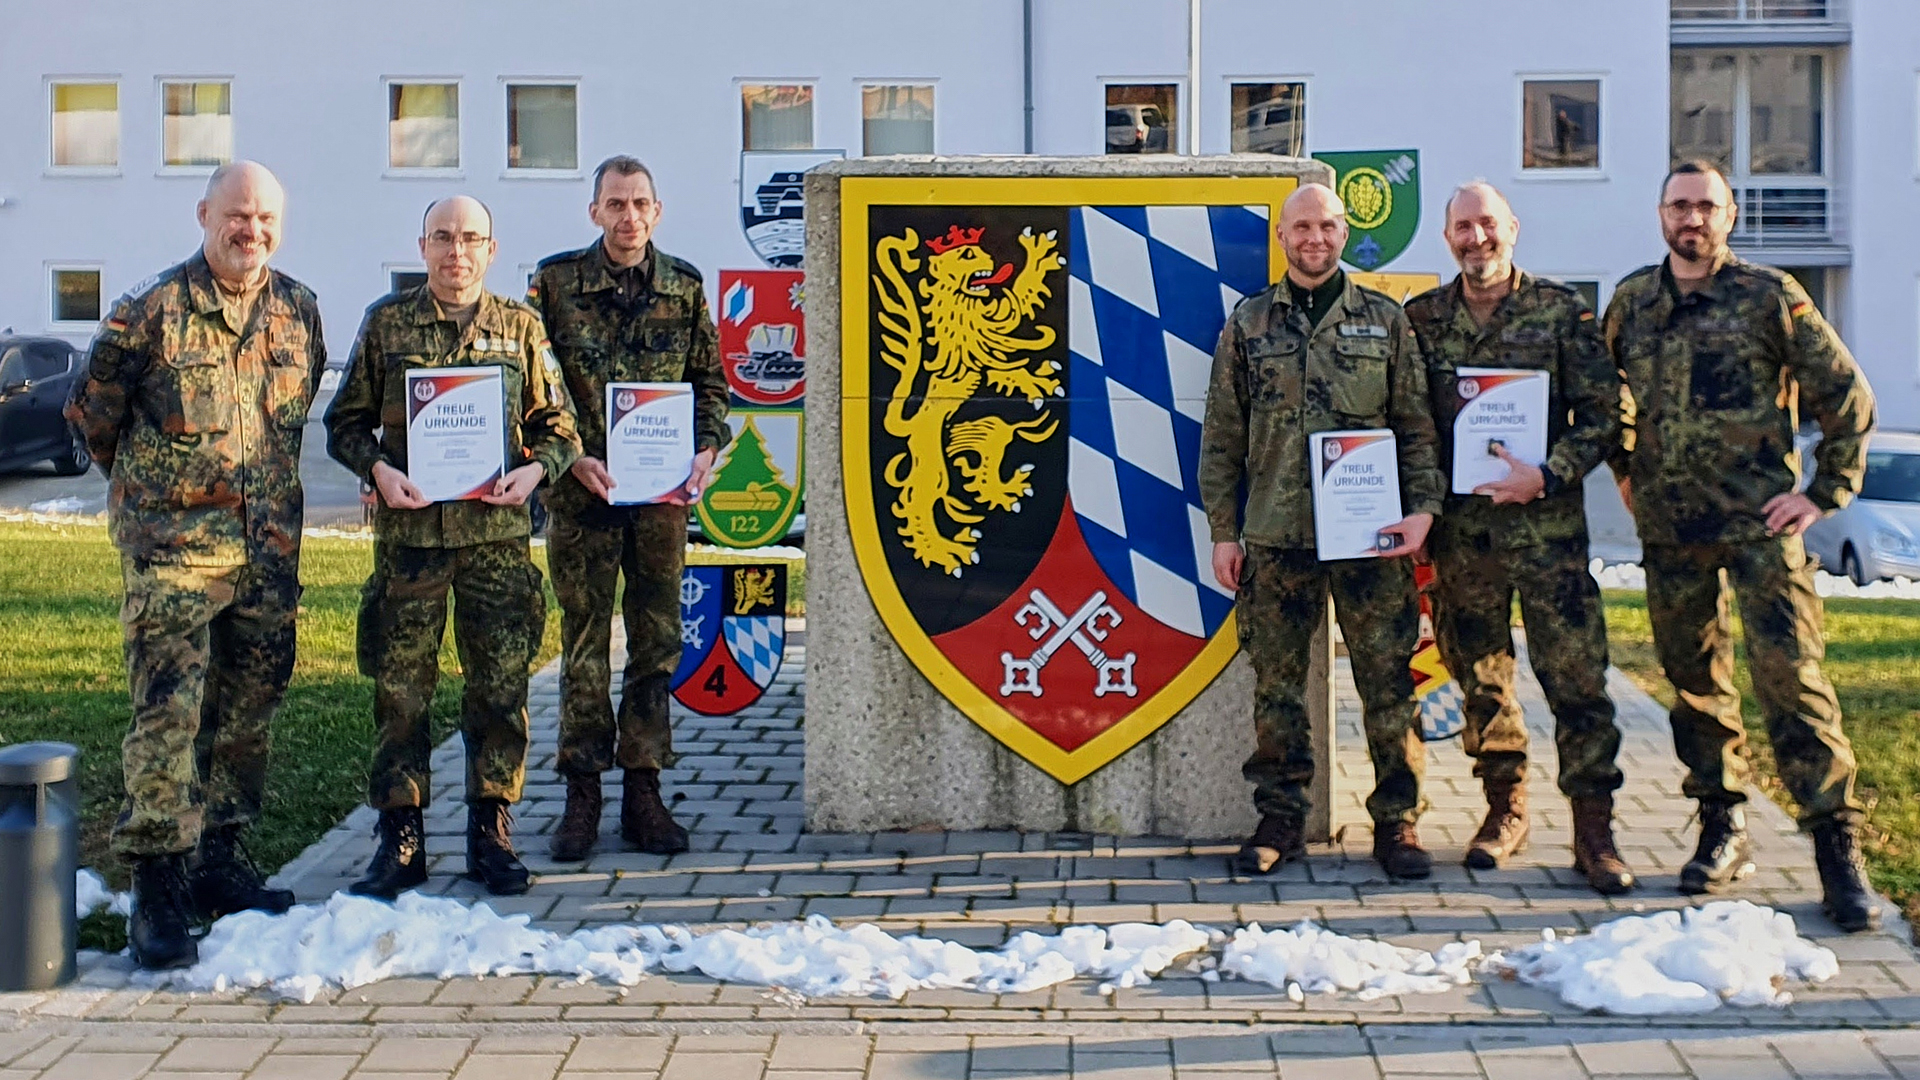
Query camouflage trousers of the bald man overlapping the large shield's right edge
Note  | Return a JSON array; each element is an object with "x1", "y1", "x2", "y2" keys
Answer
[{"x1": 1238, "y1": 544, "x2": 1427, "y2": 822}]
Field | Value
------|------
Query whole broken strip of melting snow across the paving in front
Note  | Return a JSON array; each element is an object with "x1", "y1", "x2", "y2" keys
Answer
[{"x1": 77, "y1": 883, "x2": 1839, "y2": 1017}]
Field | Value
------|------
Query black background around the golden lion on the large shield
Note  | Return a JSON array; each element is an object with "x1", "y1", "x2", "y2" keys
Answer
[{"x1": 866, "y1": 206, "x2": 1071, "y2": 636}]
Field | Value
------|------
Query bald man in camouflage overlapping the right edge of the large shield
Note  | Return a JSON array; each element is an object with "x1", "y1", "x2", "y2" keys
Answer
[{"x1": 1200, "y1": 184, "x2": 1442, "y2": 878}]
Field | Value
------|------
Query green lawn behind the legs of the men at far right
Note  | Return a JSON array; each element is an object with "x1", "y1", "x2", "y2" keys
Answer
[{"x1": 1607, "y1": 592, "x2": 1920, "y2": 919}]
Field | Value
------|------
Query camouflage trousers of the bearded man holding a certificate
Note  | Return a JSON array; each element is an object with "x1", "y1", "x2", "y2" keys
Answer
[{"x1": 1430, "y1": 521, "x2": 1624, "y2": 798}]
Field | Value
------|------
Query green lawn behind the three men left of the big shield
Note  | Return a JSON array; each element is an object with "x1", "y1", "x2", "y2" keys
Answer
[{"x1": 0, "y1": 523, "x2": 559, "y2": 886}]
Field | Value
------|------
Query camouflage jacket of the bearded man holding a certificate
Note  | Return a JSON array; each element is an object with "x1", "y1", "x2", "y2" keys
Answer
[{"x1": 1407, "y1": 269, "x2": 1620, "y2": 548}]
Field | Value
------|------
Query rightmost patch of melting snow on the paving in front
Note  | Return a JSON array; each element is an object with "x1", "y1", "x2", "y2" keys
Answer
[{"x1": 1486, "y1": 899, "x2": 1839, "y2": 1017}]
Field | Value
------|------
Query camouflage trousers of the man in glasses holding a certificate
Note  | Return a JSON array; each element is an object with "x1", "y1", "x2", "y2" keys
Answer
[{"x1": 359, "y1": 536, "x2": 547, "y2": 809}]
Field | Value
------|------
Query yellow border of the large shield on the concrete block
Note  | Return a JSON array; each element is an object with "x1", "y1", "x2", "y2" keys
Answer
[{"x1": 839, "y1": 177, "x2": 1298, "y2": 784}]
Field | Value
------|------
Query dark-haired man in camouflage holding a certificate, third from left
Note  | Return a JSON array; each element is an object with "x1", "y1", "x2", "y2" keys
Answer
[{"x1": 526, "y1": 158, "x2": 730, "y2": 861}]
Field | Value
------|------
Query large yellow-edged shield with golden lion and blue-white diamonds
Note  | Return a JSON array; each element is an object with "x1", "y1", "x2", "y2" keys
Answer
[{"x1": 841, "y1": 177, "x2": 1294, "y2": 784}]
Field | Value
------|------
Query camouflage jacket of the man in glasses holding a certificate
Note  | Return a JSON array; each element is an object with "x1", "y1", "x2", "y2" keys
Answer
[{"x1": 326, "y1": 284, "x2": 580, "y2": 548}]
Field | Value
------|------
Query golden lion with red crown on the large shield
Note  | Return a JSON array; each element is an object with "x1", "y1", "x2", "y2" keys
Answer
[{"x1": 874, "y1": 225, "x2": 1066, "y2": 577}]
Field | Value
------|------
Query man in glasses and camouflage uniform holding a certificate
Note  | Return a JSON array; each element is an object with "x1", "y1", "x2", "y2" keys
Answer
[{"x1": 326, "y1": 198, "x2": 580, "y2": 899}]
